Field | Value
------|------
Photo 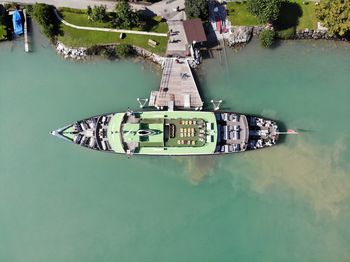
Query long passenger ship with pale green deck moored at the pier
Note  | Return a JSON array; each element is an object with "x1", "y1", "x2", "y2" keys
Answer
[{"x1": 51, "y1": 110, "x2": 279, "y2": 156}]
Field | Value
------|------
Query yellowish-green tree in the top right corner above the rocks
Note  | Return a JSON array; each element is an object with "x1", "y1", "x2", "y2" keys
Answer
[{"x1": 316, "y1": 0, "x2": 350, "y2": 36}]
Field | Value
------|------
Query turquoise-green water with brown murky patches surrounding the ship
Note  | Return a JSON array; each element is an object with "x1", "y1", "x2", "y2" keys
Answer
[{"x1": 0, "y1": 27, "x2": 350, "y2": 262}]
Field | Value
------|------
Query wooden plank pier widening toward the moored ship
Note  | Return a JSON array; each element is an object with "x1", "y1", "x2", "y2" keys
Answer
[{"x1": 149, "y1": 58, "x2": 203, "y2": 110}]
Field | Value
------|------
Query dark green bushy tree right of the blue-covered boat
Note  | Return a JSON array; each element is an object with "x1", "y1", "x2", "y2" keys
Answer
[{"x1": 33, "y1": 3, "x2": 59, "y2": 41}]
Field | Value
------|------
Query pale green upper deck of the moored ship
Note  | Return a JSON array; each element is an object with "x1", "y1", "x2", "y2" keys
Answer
[{"x1": 107, "y1": 111, "x2": 217, "y2": 155}]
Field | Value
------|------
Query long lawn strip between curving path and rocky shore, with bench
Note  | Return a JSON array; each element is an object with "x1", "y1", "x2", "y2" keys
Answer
[{"x1": 58, "y1": 24, "x2": 168, "y2": 55}]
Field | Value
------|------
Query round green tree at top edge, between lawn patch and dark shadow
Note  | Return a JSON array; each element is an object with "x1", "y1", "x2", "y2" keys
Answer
[{"x1": 247, "y1": 0, "x2": 284, "y2": 23}]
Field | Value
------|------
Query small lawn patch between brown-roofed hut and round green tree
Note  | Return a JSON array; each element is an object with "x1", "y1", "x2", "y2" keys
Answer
[{"x1": 226, "y1": 2, "x2": 259, "y2": 26}]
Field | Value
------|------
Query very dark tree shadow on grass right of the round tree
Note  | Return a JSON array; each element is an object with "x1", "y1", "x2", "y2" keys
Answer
[{"x1": 275, "y1": 2, "x2": 303, "y2": 30}]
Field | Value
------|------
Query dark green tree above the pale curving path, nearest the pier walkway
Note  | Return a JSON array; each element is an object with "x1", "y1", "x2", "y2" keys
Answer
[{"x1": 114, "y1": 0, "x2": 139, "y2": 28}]
